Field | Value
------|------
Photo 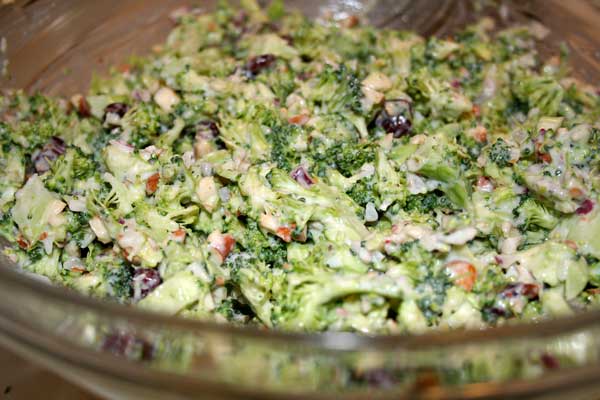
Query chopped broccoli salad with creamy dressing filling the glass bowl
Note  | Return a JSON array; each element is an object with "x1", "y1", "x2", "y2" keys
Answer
[{"x1": 0, "y1": 1, "x2": 600, "y2": 334}]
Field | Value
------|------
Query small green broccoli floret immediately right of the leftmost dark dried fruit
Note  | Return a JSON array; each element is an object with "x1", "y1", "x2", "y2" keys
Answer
[{"x1": 45, "y1": 147, "x2": 97, "y2": 194}]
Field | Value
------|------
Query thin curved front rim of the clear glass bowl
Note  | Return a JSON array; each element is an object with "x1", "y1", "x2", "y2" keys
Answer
[{"x1": 0, "y1": 262, "x2": 600, "y2": 351}]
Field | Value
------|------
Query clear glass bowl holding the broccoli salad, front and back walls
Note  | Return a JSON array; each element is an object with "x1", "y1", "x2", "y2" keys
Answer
[{"x1": 0, "y1": 0, "x2": 600, "y2": 399}]
